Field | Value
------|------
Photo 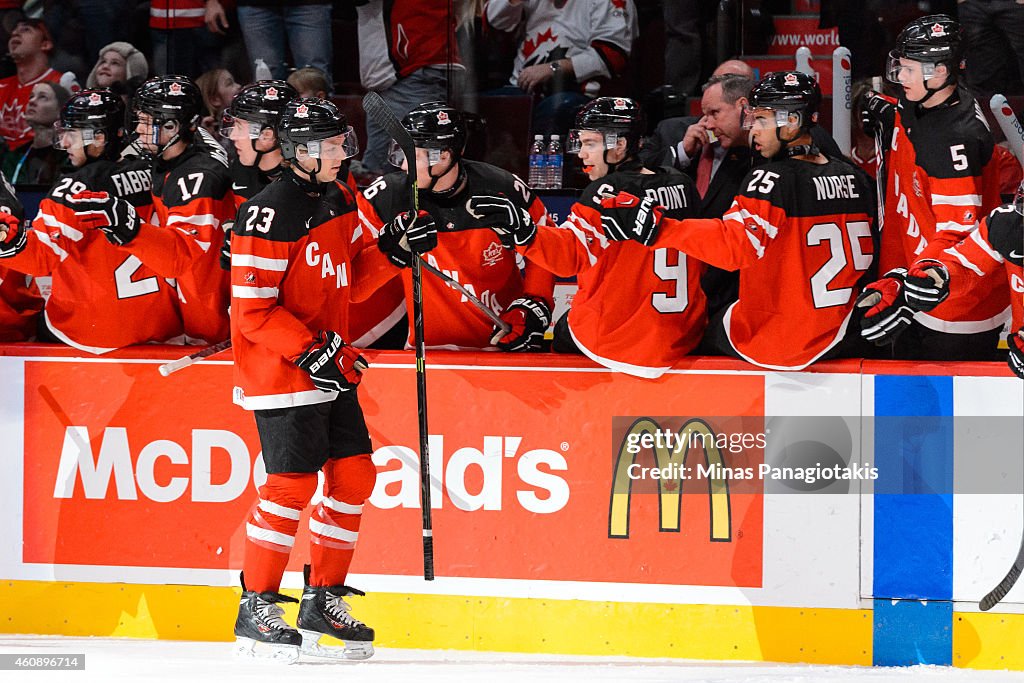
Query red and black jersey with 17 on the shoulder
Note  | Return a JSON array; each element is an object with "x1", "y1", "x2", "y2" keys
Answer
[{"x1": 121, "y1": 143, "x2": 234, "y2": 343}]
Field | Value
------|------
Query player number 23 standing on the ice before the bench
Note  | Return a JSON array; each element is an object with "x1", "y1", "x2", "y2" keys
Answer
[{"x1": 230, "y1": 98, "x2": 384, "y2": 659}]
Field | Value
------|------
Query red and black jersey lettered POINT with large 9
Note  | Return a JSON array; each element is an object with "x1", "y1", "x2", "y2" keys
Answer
[{"x1": 520, "y1": 166, "x2": 708, "y2": 378}]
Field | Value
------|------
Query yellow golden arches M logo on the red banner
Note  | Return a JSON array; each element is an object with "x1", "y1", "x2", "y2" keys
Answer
[{"x1": 608, "y1": 418, "x2": 732, "y2": 543}]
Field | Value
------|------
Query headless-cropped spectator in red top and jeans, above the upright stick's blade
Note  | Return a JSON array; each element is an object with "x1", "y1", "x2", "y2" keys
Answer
[{"x1": 356, "y1": 0, "x2": 462, "y2": 174}]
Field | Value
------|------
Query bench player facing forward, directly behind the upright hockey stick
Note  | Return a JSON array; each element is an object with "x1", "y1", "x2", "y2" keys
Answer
[{"x1": 359, "y1": 102, "x2": 554, "y2": 351}]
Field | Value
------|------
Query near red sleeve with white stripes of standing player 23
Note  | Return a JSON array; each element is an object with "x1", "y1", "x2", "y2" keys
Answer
[{"x1": 231, "y1": 232, "x2": 313, "y2": 358}]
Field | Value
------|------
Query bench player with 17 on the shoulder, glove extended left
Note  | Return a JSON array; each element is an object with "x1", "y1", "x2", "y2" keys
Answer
[{"x1": 72, "y1": 76, "x2": 234, "y2": 343}]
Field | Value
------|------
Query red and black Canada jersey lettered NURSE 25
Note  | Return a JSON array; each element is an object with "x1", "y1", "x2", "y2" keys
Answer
[{"x1": 653, "y1": 159, "x2": 873, "y2": 370}]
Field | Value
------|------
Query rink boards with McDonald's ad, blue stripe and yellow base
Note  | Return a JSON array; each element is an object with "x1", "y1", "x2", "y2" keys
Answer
[{"x1": 0, "y1": 346, "x2": 1024, "y2": 669}]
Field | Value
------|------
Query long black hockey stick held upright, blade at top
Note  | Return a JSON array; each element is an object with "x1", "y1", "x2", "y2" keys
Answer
[{"x1": 362, "y1": 91, "x2": 434, "y2": 581}]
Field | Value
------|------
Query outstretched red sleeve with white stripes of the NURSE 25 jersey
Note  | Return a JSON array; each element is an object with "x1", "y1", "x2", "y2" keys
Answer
[{"x1": 652, "y1": 195, "x2": 787, "y2": 270}]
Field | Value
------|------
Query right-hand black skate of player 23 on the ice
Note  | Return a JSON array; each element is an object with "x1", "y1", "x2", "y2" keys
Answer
[{"x1": 297, "y1": 565, "x2": 374, "y2": 659}]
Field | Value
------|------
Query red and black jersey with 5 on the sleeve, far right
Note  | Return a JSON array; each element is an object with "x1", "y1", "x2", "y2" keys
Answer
[{"x1": 879, "y1": 88, "x2": 1009, "y2": 334}]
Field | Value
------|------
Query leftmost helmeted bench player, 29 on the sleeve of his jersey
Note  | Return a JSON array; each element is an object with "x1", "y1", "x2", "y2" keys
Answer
[{"x1": 0, "y1": 90, "x2": 181, "y2": 353}]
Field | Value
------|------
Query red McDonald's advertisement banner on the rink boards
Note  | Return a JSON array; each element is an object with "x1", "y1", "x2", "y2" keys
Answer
[{"x1": 6, "y1": 353, "x2": 765, "y2": 588}]
